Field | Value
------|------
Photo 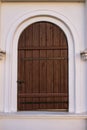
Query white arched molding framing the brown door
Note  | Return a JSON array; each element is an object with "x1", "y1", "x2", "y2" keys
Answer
[{"x1": 4, "y1": 10, "x2": 81, "y2": 112}]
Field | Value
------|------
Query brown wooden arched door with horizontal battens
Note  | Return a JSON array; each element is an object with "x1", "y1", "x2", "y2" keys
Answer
[{"x1": 17, "y1": 22, "x2": 69, "y2": 111}]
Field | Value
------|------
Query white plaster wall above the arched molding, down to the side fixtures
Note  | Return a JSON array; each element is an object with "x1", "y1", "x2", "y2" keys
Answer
[{"x1": 1, "y1": 2, "x2": 85, "y2": 49}]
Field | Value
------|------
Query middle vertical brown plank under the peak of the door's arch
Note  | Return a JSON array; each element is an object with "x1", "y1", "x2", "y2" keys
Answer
[{"x1": 40, "y1": 22, "x2": 47, "y2": 109}]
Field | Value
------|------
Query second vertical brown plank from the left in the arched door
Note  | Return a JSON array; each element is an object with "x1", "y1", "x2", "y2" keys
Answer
[{"x1": 25, "y1": 25, "x2": 33, "y2": 110}]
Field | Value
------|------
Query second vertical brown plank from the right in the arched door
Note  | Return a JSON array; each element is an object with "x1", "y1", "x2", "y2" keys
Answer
[{"x1": 53, "y1": 26, "x2": 61, "y2": 109}]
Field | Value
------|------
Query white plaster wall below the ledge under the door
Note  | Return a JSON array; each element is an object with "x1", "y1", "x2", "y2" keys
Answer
[{"x1": 0, "y1": 118, "x2": 87, "y2": 130}]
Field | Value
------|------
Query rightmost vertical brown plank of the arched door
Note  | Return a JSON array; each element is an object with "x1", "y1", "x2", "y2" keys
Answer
[{"x1": 60, "y1": 31, "x2": 68, "y2": 109}]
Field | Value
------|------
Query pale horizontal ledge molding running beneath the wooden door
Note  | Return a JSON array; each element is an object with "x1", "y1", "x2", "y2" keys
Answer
[{"x1": 0, "y1": 112, "x2": 87, "y2": 120}]
